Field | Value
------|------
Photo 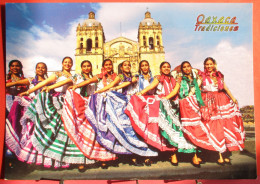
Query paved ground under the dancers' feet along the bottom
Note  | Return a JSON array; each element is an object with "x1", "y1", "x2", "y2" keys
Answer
[{"x1": 5, "y1": 127, "x2": 256, "y2": 180}]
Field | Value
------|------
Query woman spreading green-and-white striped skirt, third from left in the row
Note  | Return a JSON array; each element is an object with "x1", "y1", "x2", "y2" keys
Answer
[{"x1": 22, "y1": 57, "x2": 94, "y2": 167}]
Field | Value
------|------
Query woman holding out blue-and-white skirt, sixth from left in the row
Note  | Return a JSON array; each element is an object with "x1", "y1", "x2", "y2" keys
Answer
[{"x1": 86, "y1": 61, "x2": 157, "y2": 165}]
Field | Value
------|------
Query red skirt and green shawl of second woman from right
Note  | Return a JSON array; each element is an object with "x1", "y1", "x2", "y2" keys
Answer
[{"x1": 179, "y1": 73, "x2": 214, "y2": 150}]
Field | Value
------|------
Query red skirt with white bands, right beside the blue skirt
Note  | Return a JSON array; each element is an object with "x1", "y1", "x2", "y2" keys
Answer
[{"x1": 125, "y1": 95, "x2": 176, "y2": 151}]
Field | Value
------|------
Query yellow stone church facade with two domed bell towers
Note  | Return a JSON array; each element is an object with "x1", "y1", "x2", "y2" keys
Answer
[{"x1": 75, "y1": 11, "x2": 165, "y2": 75}]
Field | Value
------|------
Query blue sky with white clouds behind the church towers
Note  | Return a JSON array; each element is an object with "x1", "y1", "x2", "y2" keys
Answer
[{"x1": 6, "y1": 3, "x2": 254, "y2": 107}]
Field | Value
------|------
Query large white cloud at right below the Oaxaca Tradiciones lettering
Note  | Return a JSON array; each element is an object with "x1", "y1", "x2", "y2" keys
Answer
[{"x1": 191, "y1": 40, "x2": 254, "y2": 107}]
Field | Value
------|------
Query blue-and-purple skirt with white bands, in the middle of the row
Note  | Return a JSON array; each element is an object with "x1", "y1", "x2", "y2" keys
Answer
[{"x1": 86, "y1": 91, "x2": 158, "y2": 156}]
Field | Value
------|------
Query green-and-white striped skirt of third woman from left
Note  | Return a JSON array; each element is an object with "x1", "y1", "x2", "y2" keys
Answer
[{"x1": 25, "y1": 92, "x2": 95, "y2": 164}]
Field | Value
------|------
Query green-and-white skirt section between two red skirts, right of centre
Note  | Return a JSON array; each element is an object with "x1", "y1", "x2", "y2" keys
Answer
[{"x1": 158, "y1": 99, "x2": 196, "y2": 153}]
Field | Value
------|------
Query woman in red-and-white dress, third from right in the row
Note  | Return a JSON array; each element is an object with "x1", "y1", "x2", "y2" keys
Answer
[{"x1": 125, "y1": 62, "x2": 181, "y2": 164}]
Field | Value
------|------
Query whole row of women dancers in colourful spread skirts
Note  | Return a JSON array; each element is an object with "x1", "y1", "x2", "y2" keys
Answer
[{"x1": 5, "y1": 57, "x2": 245, "y2": 170}]
